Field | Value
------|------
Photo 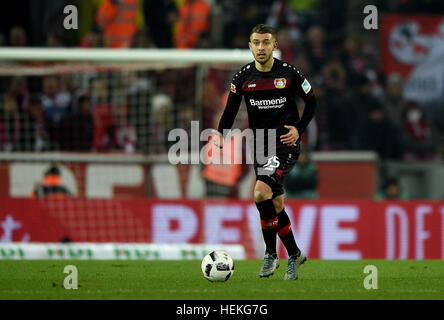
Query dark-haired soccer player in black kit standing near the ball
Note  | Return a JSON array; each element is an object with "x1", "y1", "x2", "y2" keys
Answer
[{"x1": 213, "y1": 24, "x2": 316, "y2": 280}]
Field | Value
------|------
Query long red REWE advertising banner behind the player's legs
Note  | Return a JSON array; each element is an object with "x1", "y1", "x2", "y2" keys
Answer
[{"x1": 0, "y1": 198, "x2": 444, "y2": 259}]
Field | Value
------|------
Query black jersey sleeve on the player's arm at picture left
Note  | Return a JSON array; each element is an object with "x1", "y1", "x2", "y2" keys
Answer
[{"x1": 217, "y1": 74, "x2": 243, "y2": 134}]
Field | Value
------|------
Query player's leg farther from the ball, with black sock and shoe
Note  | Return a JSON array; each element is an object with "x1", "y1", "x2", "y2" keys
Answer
[{"x1": 273, "y1": 195, "x2": 307, "y2": 280}]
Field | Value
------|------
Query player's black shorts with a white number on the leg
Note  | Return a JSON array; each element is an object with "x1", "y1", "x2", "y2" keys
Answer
[{"x1": 254, "y1": 144, "x2": 301, "y2": 199}]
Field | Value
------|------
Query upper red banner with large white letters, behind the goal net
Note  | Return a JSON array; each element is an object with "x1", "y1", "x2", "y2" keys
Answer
[{"x1": 0, "y1": 154, "x2": 377, "y2": 199}]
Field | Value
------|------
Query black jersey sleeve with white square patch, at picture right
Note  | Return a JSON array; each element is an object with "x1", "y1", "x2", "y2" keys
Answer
[{"x1": 293, "y1": 68, "x2": 316, "y2": 135}]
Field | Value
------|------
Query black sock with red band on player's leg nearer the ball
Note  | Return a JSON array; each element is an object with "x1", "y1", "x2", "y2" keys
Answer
[{"x1": 256, "y1": 199, "x2": 278, "y2": 256}]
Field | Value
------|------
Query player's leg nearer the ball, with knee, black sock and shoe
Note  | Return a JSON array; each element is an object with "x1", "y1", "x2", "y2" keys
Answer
[{"x1": 254, "y1": 180, "x2": 279, "y2": 278}]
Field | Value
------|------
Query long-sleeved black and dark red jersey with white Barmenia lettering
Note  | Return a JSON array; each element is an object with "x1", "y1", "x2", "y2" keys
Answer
[{"x1": 218, "y1": 58, "x2": 316, "y2": 147}]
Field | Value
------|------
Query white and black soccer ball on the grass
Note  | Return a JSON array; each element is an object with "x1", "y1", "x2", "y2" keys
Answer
[{"x1": 201, "y1": 250, "x2": 234, "y2": 281}]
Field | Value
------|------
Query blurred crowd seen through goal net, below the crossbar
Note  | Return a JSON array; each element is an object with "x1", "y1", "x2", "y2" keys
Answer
[{"x1": 0, "y1": 66, "x2": 196, "y2": 154}]
